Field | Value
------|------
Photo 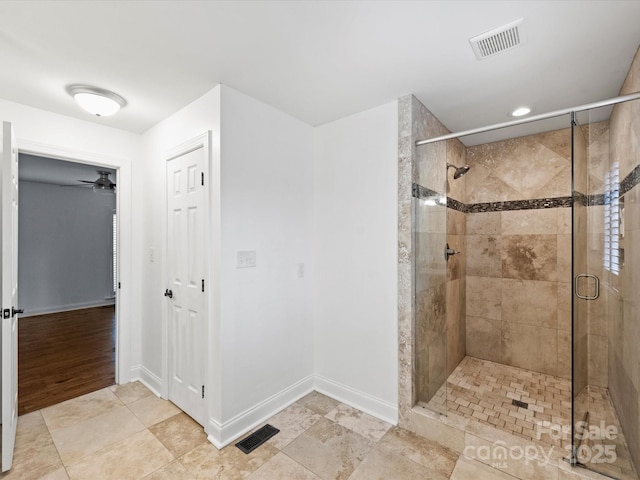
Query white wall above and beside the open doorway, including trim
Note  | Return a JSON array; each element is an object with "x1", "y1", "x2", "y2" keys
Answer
[{"x1": 0, "y1": 99, "x2": 142, "y2": 382}]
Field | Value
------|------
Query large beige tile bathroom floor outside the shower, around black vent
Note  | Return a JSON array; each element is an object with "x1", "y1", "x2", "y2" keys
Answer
[{"x1": 1, "y1": 382, "x2": 484, "y2": 480}]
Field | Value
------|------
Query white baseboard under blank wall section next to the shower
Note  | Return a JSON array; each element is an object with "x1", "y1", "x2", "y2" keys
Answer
[{"x1": 314, "y1": 375, "x2": 398, "y2": 425}]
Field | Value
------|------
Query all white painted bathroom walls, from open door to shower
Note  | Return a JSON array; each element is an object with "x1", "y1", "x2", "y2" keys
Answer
[{"x1": 0, "y1": 86, "x2": 397, "y2": 444}]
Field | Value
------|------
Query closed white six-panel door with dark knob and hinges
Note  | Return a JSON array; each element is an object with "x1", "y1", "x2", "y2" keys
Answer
[{"x1": 165, "y1": 148, "x2": 207, "y2": 425}]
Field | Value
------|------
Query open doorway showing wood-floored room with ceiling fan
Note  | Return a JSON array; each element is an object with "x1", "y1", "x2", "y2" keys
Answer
[{"x1": 18, "y1": 154, "x2": 117, "y2": 415}]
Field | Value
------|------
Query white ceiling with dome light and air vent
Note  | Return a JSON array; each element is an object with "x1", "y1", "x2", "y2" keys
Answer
[{"x1": 0, "y1": 0, "x2": 640, "y2": 141}]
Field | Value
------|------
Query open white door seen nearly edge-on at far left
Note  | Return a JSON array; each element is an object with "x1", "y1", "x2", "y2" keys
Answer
[{"x1": 0, "y1": 122, "x2": 19, "y2": 472}]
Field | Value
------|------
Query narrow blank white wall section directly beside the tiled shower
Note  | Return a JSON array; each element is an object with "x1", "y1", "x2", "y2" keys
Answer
[{"x1": 313, "y1": 101, "x2": 398, "y2": 422}]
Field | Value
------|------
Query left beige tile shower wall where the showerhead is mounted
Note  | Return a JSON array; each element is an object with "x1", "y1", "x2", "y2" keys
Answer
[{"x1": 399, "y1": 97, "x2": 466, "y2": 408}]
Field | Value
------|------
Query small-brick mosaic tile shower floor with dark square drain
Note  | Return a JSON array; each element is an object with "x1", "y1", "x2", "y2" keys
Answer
[{"x1": 422, "y1": 357, "x2": 638, "y2": 480}]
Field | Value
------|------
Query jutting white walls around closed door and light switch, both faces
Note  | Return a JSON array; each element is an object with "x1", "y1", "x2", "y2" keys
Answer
[{"x1": 141, "y1": 86, "x2": 313, "y2": 445}]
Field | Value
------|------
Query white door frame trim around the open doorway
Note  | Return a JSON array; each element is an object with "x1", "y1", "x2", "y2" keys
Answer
[{"x1": 16, "y1": 138, "x2": 133, "y2": 384}]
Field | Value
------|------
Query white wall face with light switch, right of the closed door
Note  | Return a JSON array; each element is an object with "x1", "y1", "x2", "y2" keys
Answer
[{"x1": 220, "y1": 85, "x2": 313, "y2": 424}]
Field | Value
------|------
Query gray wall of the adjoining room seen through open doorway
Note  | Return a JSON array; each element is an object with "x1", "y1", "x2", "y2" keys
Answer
[{"x1": 18, "y1": 181, "x2": 116, "y2": 315}]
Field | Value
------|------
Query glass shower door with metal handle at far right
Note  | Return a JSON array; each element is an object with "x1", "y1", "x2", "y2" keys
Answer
[{"x1": 571, "y1": 100, "x2": 640, "y2": 480}]
